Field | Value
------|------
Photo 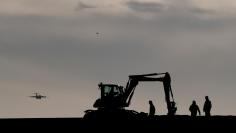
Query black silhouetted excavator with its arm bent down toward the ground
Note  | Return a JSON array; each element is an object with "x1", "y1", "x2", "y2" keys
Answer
[{"x1": 84, "y1": 72, "x2": 177, "y2": 119}]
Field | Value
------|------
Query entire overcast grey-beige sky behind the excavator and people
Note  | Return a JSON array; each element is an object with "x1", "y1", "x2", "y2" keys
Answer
[{"x1": 0, "y1": 0, "x2": 236, "y2": 118}]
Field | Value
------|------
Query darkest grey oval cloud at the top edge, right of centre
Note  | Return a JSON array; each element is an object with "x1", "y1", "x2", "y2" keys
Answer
[{"x1": 126, "y1": 1, "x2": 167, "y2": 12}]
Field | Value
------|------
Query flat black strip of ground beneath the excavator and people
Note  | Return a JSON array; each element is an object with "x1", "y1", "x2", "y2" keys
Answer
[{"x1": 0, "y1": 116, "x2": 236, "y2": 132}]
